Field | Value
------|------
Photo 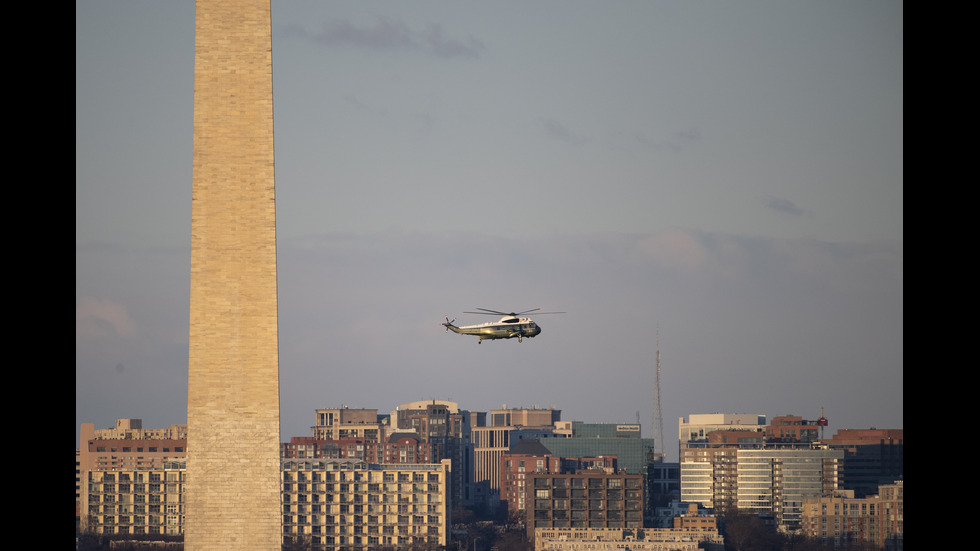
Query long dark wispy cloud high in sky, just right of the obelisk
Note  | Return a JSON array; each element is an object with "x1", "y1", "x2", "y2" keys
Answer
[{"x1": 283, "y1": 17, "x2": 485, "y2": 58}]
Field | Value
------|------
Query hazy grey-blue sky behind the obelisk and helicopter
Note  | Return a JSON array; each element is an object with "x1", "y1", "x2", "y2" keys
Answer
[{"x1": 75, "y1": 1, "x2": 904, "y2": 455}]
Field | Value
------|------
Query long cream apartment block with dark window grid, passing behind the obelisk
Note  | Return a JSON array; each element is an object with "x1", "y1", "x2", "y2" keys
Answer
[{"x1": 82, "y1": 460, "x2": 452, "y2": 551}]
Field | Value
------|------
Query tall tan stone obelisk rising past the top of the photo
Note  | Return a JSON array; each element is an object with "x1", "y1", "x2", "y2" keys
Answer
[{"x1": 184, "y1": 0, "x2": 282, "y2": 551}]
